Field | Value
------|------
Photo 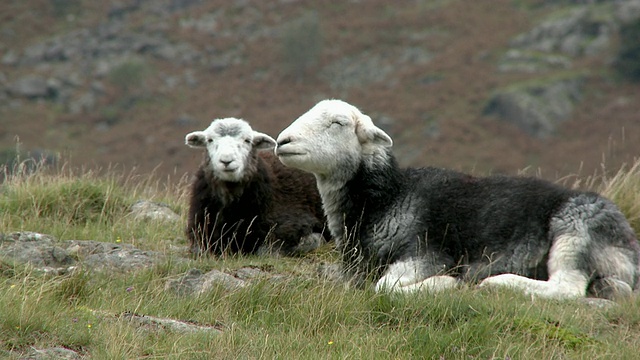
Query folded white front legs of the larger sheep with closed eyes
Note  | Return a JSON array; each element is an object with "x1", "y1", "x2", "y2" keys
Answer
[{"x1": 376, "y1": 260, "x2": 458, "y2": 293}]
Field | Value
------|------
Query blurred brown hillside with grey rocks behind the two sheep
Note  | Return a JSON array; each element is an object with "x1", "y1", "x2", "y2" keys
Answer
[{"x1": 0, "y1": 0, "x2": 640, "y2": 180}]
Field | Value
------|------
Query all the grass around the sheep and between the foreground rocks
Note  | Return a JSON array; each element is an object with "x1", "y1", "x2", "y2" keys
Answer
[{"x1": 0, "y1": 159, "x2": 640, "y2": 359}]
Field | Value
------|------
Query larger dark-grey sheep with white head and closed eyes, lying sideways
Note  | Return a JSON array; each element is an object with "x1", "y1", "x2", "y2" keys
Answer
[{"x1": 275, "y1": 100, "x2": 640, "y2": 299}]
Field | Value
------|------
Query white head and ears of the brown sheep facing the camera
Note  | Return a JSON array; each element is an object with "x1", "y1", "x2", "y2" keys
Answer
[{"x1": 185, "y1": 118, "x2": 275, "y2": 182}]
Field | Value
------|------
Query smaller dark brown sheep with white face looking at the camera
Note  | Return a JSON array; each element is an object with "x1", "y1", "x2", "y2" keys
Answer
[{"x1": 185, "y1": 118, "x2": 325, "y2": 255}]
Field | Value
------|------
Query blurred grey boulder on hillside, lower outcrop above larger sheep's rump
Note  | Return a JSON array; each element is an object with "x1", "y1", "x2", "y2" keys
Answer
[{"x1": 484, "y1": 76, "x2": 584, "y2": 138}]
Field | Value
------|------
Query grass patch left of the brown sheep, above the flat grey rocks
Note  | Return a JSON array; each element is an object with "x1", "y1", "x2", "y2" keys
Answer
[{"x1": 0, "y1": 163, "x2": 186, "y2": 250}]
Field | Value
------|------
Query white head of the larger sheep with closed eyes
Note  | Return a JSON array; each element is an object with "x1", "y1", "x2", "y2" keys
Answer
[{"x1": 276, "y1": 100, "x2": 392, "y2": 176}]
